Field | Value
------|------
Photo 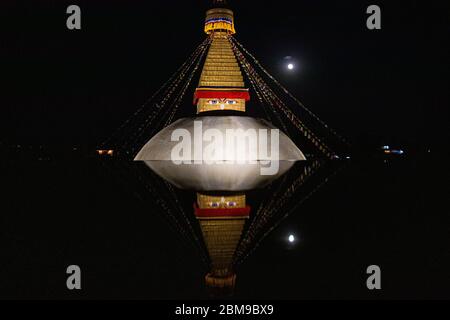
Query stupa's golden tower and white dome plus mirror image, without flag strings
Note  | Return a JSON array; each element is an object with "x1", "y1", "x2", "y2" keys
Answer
[{"x1": 135, "y1": 1, "x2": 306, "y2": 295}]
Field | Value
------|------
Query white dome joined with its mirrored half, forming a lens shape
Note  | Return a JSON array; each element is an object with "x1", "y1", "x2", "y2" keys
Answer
[{"x1": 134, "y1": 116, "x2": 306, "y2": 191}]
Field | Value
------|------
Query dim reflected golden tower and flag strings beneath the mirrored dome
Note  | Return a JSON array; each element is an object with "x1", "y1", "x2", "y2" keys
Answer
[{"x1": 121, "y1": 160, "x2": 340, "y2": 297}]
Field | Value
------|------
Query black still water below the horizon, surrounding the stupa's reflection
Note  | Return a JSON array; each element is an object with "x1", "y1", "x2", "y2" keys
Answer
[{"x1": 0, "y1": 158, "x2": 450, "y2": 299}]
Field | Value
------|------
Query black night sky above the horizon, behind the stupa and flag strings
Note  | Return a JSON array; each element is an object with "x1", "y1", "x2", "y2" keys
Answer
[{"x1": 0, "y1": 0, "x2": 449, "y2": 149}]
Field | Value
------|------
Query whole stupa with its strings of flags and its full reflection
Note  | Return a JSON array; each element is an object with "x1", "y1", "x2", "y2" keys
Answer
[{"x1": 104, "y1": 0, "x2": 348, "y2": 294}]
